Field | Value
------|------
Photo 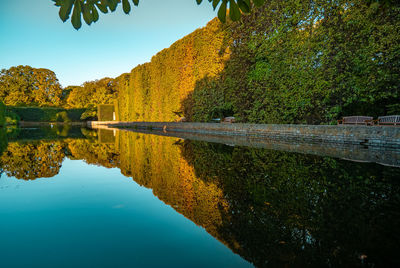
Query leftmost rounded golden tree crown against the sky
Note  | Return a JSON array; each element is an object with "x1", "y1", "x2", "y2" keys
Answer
[{"x1": 0, "y1": 65, "x2": 62, "y2": 106}]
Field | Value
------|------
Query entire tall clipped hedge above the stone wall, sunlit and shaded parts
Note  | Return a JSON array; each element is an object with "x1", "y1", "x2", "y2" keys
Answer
[{"x1": 116, "y1": 0, "x2": 400, "y2": 124}]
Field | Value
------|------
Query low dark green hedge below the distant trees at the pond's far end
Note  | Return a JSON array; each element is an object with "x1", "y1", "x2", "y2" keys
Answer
[{"x1": 8, "y1": 107, "x2": 85, "y2": 122}]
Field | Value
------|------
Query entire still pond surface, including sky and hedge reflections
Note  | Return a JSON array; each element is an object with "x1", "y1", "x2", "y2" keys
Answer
[{"x1": 0, "y1": 127, "x2": 400, "y2": 267}]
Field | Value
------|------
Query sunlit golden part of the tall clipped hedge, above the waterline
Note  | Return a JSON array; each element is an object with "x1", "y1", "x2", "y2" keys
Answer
[{"x1": 115, "y1": 19, "x2": 229, "y2": 121}]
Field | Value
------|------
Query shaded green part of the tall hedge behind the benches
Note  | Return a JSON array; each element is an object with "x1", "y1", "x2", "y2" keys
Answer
[{"x1": 185, "y1": 0, "x2": 400, "y2": 124}]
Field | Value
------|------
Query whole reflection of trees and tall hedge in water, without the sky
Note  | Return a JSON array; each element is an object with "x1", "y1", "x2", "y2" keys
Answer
[{"x1": 0, "y1": 126, "x2": 400, "y2": 267}]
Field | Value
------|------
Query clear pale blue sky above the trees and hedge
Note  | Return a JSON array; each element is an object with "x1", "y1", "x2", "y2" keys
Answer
[{"x1": 0, "y1": 0, "x2": 216, "y2": 86}]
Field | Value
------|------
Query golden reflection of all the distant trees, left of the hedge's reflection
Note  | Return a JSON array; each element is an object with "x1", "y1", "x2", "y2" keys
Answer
[{"x1": 0, "y1": 138, "x2": 119, "y2": 180}]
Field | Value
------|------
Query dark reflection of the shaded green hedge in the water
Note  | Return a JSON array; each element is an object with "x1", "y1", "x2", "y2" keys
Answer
[{"x1": 182, "y1": 142, "x2": 400, "y2": 266}]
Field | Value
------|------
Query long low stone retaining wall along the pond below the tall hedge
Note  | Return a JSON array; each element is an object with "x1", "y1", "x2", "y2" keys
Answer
[{"x1": 88, "y1": 121, "x2": 400, "y2": 148}]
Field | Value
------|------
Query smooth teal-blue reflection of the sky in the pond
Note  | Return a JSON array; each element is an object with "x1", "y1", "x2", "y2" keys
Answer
[{"x1": 0, "y1": 159, "x2": 249, "y2": 267}]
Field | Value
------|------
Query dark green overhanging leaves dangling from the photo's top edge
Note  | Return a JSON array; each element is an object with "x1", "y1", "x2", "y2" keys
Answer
[{"x1": 53, "y1": 0, "x2": 265, "y2": 30}]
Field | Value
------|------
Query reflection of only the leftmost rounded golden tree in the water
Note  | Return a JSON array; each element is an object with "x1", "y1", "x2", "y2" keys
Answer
[{"x1": 0, "y1": 141, "x2": 65, "y2": 180}]
